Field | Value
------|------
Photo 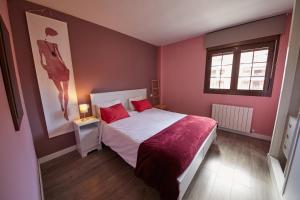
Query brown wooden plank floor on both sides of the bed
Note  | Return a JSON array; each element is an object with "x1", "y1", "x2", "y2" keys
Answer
[{"x1": 41, "y1": 132, "x2": 275, "y2": 200}]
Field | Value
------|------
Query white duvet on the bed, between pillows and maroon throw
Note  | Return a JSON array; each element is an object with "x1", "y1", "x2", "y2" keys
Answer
[{"x1": 101, "y1": 108, "x2": 186, "y2": 168}]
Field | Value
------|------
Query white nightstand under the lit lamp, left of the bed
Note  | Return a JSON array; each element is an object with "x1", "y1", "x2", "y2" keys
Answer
[{"x1": 74, "y1": 117, "x2": 101, "y2": 157}]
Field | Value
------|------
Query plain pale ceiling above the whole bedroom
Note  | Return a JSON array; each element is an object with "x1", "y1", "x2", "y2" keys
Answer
[{"x1": 28, "y1": 0, "x2": 294, "y2": 46}]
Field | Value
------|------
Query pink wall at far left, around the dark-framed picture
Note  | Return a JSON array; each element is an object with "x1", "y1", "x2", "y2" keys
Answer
[{"x1": 0, "y1": 0, "x2": 41, "y2": 200}]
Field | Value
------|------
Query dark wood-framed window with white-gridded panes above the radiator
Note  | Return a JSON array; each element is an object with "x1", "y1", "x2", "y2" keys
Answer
[{"x1": 204, "y1": 36, "x2": 279, "y2": 96}]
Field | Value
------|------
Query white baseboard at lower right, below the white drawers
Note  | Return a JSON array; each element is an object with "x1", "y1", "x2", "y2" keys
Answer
[{"x1": 268, "y1": 154, "x2": 284, "y2": 200}]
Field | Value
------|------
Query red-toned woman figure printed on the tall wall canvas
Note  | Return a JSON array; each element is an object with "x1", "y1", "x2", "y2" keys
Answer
[{"x1": 37, "y1": 27, "x2": 70, "y2": 120}]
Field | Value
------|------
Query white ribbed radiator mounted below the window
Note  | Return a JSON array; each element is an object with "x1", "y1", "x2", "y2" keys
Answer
[{"x1": 212, "y1": 104, "x2": 253, "y2": 133}]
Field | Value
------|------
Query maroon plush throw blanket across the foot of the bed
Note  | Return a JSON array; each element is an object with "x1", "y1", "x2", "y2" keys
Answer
[{"x1": 135, "y1": 115, "x2": 216, "y2": 200}]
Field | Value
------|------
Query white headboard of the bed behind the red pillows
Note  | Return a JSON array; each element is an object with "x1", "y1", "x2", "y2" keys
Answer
[{"x1": 90, "y1": 88, "x2": 147, "y2": 116}]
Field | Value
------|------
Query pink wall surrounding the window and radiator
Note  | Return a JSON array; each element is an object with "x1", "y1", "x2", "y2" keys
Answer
[{"x1": 162, "y1": 13, "x2": 291, "y2": 136}]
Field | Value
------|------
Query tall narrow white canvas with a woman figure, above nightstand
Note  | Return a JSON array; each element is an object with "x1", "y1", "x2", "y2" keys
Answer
[{"x1": 26, "y1": 12, "x2": 79, "y2": 138}]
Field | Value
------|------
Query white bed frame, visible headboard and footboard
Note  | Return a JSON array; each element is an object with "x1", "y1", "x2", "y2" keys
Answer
[{"x1": 90, "y1": 89, "x2": 217, "y2": 200}]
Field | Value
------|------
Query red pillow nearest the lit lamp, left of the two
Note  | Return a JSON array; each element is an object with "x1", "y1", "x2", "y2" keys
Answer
[{"x1": 100, "y1": 103, "x2": 129, "y2": 123}]
